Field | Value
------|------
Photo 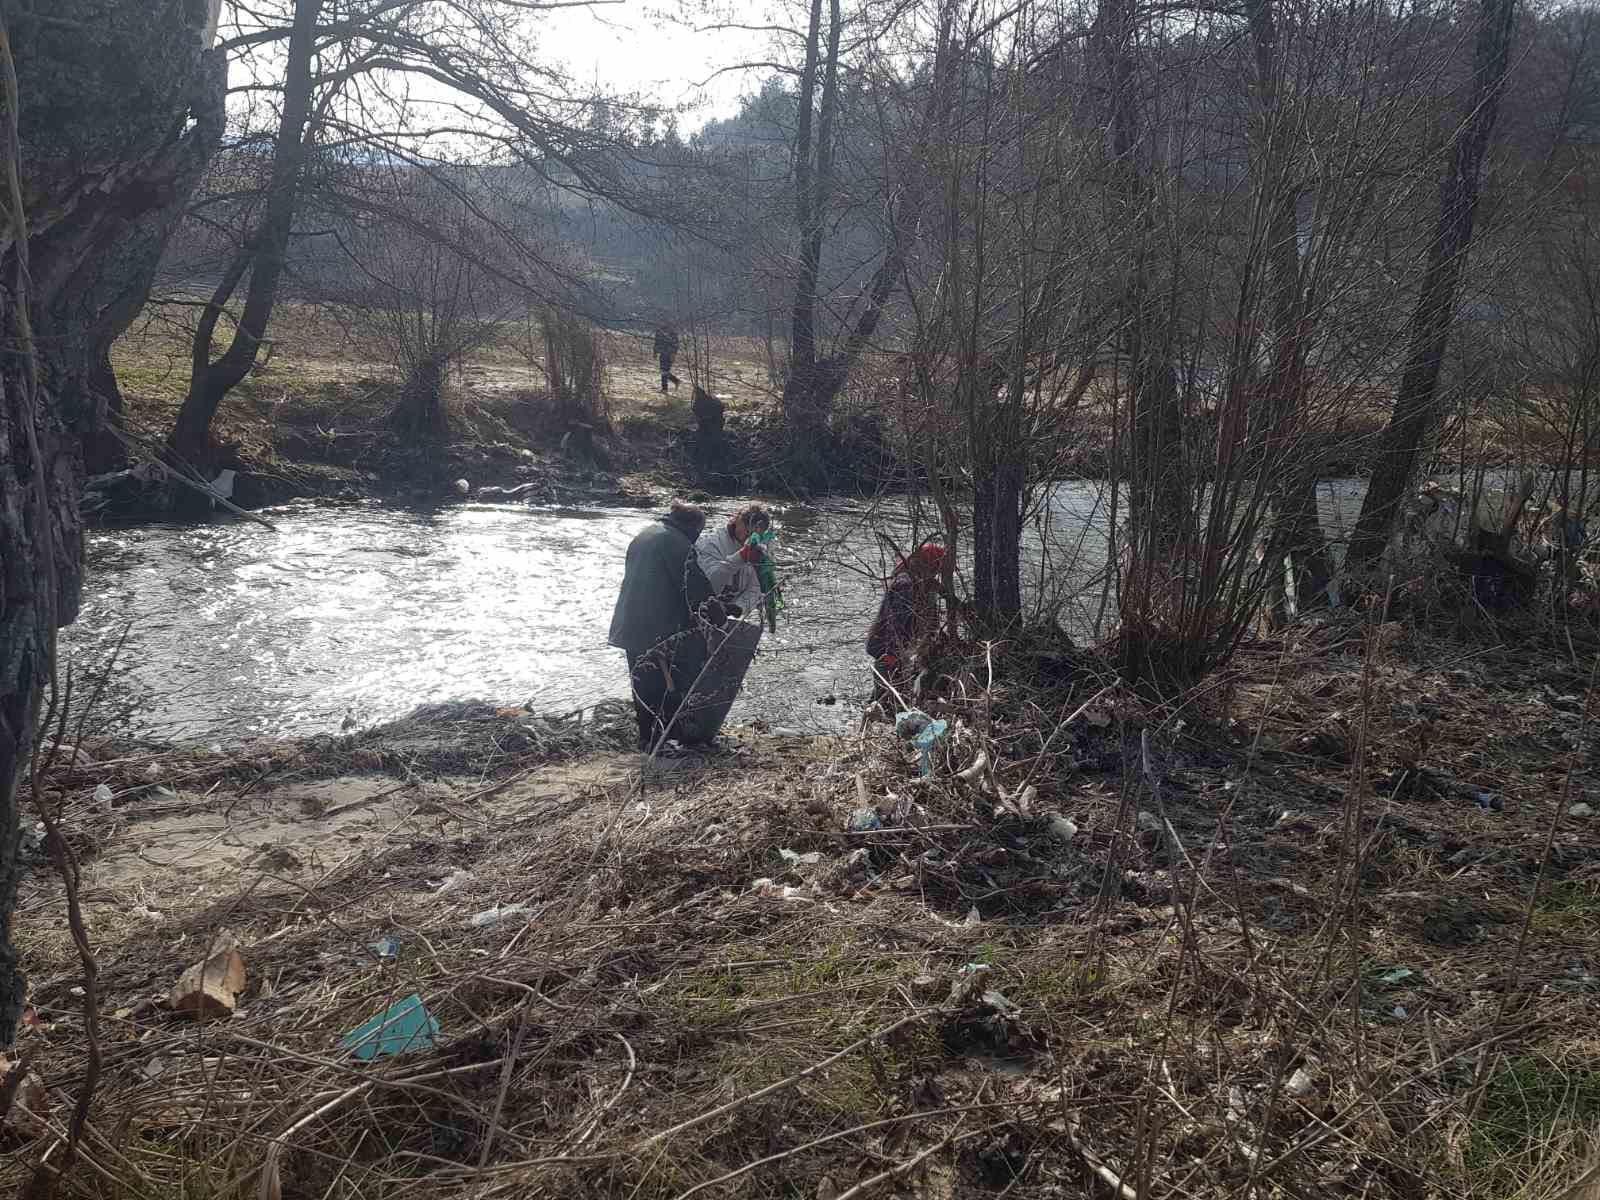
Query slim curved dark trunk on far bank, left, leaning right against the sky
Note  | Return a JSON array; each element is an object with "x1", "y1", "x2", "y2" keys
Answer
[{"x1": 168, "y1": 0, "x2": 323, "y2": 462}]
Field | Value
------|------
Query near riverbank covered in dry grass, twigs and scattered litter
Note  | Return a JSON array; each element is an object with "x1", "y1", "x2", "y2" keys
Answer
[{"x1": 5, "y1": 621, "x2": 1600, "y2": 1200}]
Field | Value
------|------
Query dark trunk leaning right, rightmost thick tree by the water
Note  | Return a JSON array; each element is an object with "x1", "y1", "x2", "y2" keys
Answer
[{"x1": 1347, "y1": 0, "x2": 1517, "y2": 568}]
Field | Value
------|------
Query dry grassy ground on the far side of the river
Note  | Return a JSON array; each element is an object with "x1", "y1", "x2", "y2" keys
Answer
[{"x1": 112, "y1": 304, "x2": 1593, "y2": 515}]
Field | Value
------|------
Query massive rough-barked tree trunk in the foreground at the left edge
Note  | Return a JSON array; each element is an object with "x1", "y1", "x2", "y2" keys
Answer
[{"x1": 0, "y1": 0, "x2": 226, "y2": 1045}]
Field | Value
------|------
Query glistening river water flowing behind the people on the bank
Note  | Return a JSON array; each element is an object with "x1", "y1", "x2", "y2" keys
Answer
[{"x1": 62, "y1": 483, "x2": 1358, "y2": 744}]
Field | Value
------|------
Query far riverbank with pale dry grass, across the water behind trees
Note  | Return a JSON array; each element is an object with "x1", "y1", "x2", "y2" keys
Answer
[{"x1": 100, "y1": 304, "x2": 1587, "y2": 523}]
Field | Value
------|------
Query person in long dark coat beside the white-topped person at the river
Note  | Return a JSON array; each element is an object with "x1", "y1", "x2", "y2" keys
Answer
[{"x1": 608, "y1": 501, "x2": 717, "y2": 752}]
